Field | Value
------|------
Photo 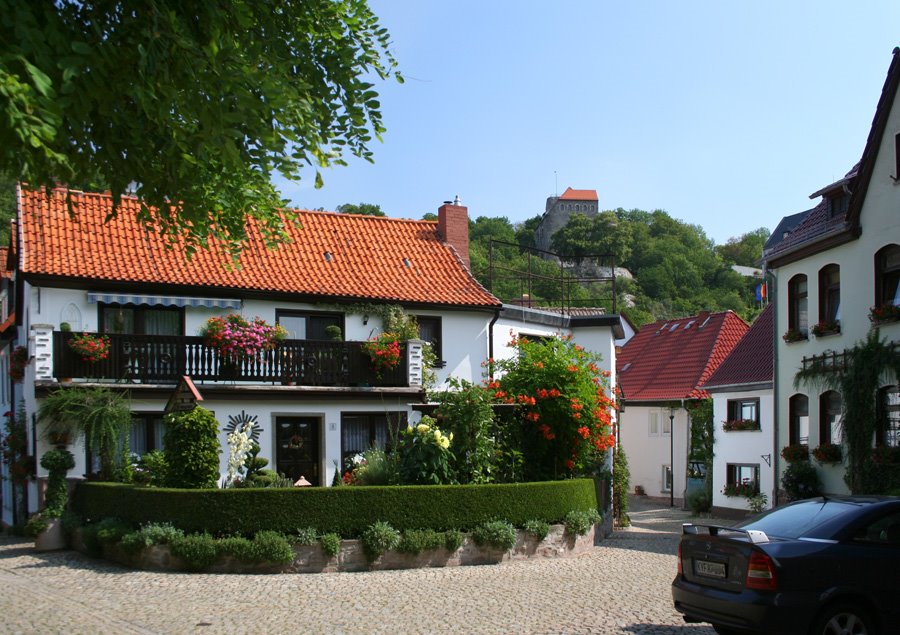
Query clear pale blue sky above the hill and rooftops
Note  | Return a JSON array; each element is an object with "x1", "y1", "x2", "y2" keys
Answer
[{"x1": 276, "y1": 0, "x2": 900, "y2": 244}]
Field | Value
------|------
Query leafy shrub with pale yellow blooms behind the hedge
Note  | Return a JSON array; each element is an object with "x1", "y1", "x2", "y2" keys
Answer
[{"x1": 397, "y1": 416, "x2": 454, "y2": 485}]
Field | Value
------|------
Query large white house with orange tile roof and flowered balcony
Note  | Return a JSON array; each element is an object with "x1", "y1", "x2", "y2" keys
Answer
[{"x1": 0, "y1": 188, "x2": 621, "y2": 524}]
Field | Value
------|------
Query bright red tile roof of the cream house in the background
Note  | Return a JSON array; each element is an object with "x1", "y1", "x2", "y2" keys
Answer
[{"x1": 616, "y1": 311, "x2": 749, "y2": 404}]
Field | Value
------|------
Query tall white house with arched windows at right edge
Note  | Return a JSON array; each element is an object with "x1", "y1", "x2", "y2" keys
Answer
[{"x1": 764, "y1": 49, "x2": 900, "y2": 500}]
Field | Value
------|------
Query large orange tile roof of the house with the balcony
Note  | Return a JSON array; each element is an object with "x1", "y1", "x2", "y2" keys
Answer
[{"x1": 18, "y1": 188, "x2": 500, "y2": 307}]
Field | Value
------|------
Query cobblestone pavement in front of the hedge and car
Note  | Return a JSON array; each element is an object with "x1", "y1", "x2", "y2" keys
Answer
[{"x1": 0, "y1": 500, "x2": 736, "y2": 635}]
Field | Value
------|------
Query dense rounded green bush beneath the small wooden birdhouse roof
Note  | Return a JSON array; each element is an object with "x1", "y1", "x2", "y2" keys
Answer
[{"x1": 164, "y1": 406, "x2": 221, "y2": 489}]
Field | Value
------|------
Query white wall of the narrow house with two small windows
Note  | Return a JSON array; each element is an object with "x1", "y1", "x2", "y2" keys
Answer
[{"x1": 712, "y1": 388, "x2": 780, "y2": 509}]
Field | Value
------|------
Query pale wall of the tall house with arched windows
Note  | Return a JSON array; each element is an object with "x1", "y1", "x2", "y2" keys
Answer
[{"x1": 775, "y1": 82, "x2": 900, "y2": 494}]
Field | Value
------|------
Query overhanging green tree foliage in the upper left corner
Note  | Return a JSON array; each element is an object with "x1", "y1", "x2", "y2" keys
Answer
[{"x1": 0, "y1": 0, "x2": 402, "y2": 253}]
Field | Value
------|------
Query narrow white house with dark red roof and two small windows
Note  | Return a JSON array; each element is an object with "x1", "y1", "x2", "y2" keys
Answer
[{"x1": 703, "y1": 304, "x2": 776, "y2": 511}]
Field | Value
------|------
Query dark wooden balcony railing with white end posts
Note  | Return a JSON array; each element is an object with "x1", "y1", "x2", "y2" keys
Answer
[{"x1": 46, "y1": 329, "x2": 421, "y2": 388}]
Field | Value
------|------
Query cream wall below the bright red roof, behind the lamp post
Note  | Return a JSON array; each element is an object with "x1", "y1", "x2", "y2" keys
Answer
[{"x1": 619, "y1": 403, "x2": 690, "y2": 499}]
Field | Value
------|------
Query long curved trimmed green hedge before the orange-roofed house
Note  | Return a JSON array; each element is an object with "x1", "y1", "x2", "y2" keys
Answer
[{"x1": 73, "y1": 479, "x2": 597, "y2": 538}]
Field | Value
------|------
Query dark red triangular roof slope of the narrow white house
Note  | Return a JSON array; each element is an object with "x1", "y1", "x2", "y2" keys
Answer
[{"x1": 703, "y1": 304, "x2": 775, "y2": 389}]
